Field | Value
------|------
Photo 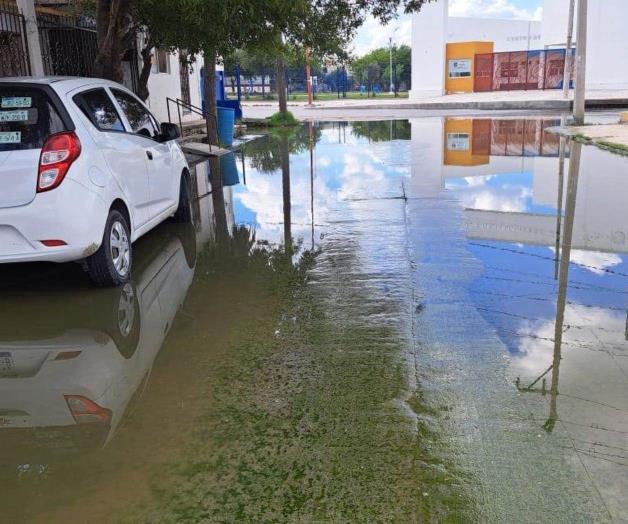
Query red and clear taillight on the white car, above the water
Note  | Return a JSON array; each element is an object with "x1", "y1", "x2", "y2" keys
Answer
[{"x1": 37, "y1": 132, "x2": 81, "y2": 193}]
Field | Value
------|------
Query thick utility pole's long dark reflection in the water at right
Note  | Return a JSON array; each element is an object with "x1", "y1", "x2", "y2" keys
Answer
[{"x1": 544, "y1": 142, "x2": 582, "y2": 431}]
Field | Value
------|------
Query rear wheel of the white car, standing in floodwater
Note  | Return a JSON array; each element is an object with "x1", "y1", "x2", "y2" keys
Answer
[{"x1": 86, "y1": 209, "x2": 133, "y2": 287}]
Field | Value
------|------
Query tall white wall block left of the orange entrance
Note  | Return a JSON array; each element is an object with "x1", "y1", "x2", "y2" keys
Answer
[{"x1": 410, "y1": 0, "x2": 449, "y2": 99}]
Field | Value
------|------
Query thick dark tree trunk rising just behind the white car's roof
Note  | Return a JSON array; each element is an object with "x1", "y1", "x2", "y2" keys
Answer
[{"x1": 94, "y1": 0, "x2": 131, "y2": 82}]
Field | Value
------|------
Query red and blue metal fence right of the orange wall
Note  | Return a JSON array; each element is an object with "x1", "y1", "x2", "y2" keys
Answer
[{"x1": 474, "y1": 49, "x2": 574, "y2": 92}]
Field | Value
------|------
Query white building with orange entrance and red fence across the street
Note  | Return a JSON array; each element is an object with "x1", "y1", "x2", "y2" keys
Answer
[{"x1": 410, "y1": 0, "x2": 628, "y2": 99}]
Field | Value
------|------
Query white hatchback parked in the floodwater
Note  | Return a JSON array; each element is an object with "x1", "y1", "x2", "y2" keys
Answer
[{"x1": 0, "y1": 77, "x2": 191, "y2": 286}]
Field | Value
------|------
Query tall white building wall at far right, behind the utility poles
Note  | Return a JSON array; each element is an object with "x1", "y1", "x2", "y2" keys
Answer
[{"x1": 542, "y1": 0, "x2": 628, "y2": 89}]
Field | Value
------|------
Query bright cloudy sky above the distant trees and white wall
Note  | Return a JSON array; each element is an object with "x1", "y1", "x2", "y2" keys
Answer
[{"x1": 353, "y1": 0, "x2": 543, "y2": 55}]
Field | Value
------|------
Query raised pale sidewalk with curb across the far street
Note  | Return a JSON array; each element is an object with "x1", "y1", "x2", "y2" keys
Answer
[{"x1": 242, "y1": 89, "x2": 628, "y2": 119}]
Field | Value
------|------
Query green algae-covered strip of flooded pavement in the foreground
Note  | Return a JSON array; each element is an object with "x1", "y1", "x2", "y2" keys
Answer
[{"x1": 131, "y1": 239, "x2": 476, "y2": 522}]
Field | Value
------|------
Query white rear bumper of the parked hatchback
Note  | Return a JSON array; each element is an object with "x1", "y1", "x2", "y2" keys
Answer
[{"x1": 0, "y1": 178, "x2": 108, "y2": 263}]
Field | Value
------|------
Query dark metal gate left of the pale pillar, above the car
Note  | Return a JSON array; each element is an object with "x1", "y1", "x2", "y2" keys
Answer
[{"x1": 0, "y1": 2, "x2": 31, "y2": 77}]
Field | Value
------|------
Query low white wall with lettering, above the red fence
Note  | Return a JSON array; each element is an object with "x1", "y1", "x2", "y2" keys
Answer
[{"x1": 447, "y1": 17, "x2": 543, "y2": 52}]
